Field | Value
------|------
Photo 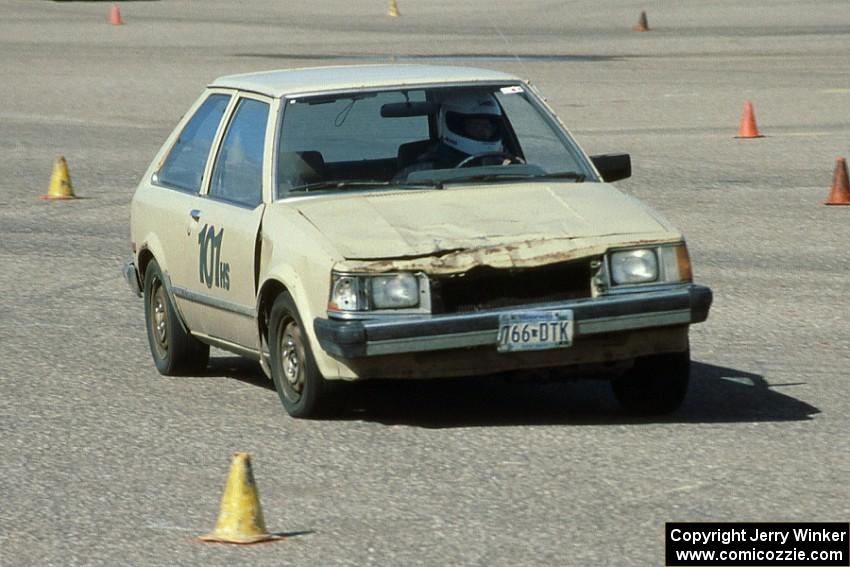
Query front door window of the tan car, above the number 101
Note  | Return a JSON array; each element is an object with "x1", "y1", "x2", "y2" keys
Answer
[{"x1": 209, "y1": 98, "x2": 269, "y2": 207}]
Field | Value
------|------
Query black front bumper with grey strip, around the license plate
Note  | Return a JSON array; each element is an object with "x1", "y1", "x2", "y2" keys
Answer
[{"x1": 313, "y1": 284, "x2": 712, "y2": 358}]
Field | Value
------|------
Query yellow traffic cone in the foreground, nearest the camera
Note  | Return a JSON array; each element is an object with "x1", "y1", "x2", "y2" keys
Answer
[{"x1": 198, "y1": 453, "x2": 283, "y2": 543}]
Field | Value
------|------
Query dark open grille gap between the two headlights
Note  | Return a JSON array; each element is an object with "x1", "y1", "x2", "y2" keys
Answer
[{"x1": 431, "y1": 258, "x2": 598, "y2": 313}]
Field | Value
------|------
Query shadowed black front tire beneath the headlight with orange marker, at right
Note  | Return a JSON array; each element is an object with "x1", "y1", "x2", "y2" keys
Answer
[{"x1": 611, "y1": 350, "x2": 691, "y2": 415}]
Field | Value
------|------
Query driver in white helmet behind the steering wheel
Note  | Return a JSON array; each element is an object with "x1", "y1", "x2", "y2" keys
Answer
[{"x1": 396, "y1": 91, "x2": 504, "y2": 178}]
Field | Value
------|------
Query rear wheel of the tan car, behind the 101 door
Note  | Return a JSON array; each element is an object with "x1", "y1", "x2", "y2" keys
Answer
[{"x1": 144, "y1": 260, "x2": 210, "y2": 376}]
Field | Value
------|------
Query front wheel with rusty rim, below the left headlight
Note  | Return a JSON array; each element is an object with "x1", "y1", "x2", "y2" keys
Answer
[{"x1": 269, "y1": 292, "x2": 327, "y2": 418}]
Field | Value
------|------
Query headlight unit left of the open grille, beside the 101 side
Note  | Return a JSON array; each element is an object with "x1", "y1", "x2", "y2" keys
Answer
[{"x1": 328, "y1": 273, "x2": 424, "y2": 311}]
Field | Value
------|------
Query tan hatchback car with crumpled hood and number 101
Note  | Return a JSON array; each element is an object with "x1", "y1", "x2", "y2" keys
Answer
[{"x1": 124, "y1": 65, "x2": 712, "y2": 417}]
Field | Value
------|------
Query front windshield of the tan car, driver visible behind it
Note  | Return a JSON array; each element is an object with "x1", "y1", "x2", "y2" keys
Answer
[{"x1": 277, "y1": 84, "x2": 594, "y2": 197}]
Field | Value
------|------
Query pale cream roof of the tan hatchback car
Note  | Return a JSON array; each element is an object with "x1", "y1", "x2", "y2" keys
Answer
[{"x1": 209, "y1": 65, "x2": 519, "y2": 97}]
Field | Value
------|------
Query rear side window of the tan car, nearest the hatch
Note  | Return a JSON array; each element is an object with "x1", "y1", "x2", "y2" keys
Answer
[{"x1": 156, "y1": 94, "x2": 230, "y2": 193}]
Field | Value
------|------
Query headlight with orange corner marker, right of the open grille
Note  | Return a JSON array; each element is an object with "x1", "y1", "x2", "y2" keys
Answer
[{"x1": 608, "y1": 242, "x2": 693, "y2": 285}]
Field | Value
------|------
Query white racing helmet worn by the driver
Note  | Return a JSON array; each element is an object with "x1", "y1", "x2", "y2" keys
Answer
[{"x1": 438, "y1": 91, "x2": 502, "y2": 155}]
